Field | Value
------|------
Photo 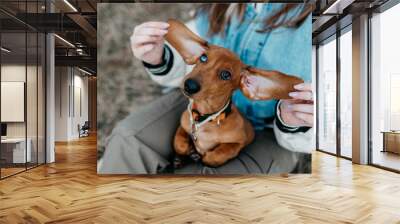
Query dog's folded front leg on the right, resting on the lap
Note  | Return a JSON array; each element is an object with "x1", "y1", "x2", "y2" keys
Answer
[{"x1": 203, "y1": 143, "x2": 243, "y2": 167}]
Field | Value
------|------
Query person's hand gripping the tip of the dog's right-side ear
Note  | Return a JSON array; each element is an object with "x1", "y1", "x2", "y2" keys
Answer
[{"x1": 280, "y1": 83, "x2": 314, "y2": 127}]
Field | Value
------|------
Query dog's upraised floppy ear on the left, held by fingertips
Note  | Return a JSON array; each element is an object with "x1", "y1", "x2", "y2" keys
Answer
[{"x1": 166, "y1": 19, "x2": 207, "y2": 65}]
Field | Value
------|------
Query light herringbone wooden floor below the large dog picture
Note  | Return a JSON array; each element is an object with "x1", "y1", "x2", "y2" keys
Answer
[{"x1": 0, "y1": 134, "x2": 400, "y2": 224}]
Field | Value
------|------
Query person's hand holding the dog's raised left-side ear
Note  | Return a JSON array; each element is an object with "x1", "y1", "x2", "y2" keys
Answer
[{"x1": 131, "y1": 22, "x2": 169, "y2": 65}]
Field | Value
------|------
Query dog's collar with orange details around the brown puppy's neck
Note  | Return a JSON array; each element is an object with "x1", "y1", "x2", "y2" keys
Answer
[{"x1": 187, "y1": 99, "x2": 232, "y2": 141}]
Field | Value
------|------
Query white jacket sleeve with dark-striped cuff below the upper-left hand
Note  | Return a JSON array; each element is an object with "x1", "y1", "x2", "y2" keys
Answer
[{"x1": 143, "y1": 20, "x2": 198, "y2": 87}]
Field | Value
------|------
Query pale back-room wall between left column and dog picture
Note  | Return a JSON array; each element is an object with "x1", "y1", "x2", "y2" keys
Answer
[{"x1": 55, "y1": 67, "x2": 88, "y2": 141}]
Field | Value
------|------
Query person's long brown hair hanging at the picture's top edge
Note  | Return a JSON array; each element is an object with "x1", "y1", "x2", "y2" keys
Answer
[{"x1": 196, "y1": 1, "x2": 314, "y2": 36}]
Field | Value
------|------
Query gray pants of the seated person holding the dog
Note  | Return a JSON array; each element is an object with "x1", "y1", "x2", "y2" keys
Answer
[{"x1": 98, "y1": 91, "x2": 310, "y2": 174}]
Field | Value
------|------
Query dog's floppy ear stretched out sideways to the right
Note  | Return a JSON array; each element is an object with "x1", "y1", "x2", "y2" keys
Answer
[{"x1": 240, "y1": 67, "x2": 304, "y2": 100}]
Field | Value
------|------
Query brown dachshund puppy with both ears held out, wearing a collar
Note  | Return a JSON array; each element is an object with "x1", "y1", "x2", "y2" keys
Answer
[{"x1": 166, "y1": 19, "x2": 303, "y2": 167}]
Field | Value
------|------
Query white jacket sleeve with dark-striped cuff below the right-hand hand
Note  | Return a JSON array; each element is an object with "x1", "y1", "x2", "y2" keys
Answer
[{"x1": 274, "y1": 101, "x2": 315, "y2": 153}]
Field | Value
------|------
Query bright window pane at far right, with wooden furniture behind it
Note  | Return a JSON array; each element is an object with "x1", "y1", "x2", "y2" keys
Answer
[{"x1": 370, "y1": 4, "x2": 400, "y2": 170}]
